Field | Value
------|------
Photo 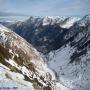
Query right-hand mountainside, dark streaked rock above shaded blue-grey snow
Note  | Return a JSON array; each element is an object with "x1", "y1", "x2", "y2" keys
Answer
[{"x1": 43, "y1": 15, "x2": 90, "y2": 90}]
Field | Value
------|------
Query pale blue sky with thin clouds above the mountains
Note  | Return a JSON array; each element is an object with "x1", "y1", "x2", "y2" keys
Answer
[{"x1": 0, "y1": 0, "x2": 90, "y2": 16}]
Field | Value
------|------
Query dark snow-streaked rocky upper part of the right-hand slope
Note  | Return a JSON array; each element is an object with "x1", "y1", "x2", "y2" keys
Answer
[{"x1": 67, "y1": 15, "x2": 90, "y2": 62}]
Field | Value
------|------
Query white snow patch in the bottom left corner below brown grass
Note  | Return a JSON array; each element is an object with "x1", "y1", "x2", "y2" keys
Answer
[{"x1": 0, "y1": 64, "x2": 34, "y2": 90}]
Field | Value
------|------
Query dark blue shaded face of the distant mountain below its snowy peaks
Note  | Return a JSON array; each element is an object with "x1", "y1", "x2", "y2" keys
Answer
[{"x1": 9, "y1": 20, "x2": 67, "y2": 54}]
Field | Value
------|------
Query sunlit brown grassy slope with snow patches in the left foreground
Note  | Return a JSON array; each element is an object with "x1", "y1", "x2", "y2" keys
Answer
[{"x1": 0, "y1": 25, "x2": 62, "y2": 90}]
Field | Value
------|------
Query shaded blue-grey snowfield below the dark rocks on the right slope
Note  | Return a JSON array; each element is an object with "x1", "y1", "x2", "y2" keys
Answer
[{"x1": 42, "y1": 44, "x2": 90, "y2": 90}]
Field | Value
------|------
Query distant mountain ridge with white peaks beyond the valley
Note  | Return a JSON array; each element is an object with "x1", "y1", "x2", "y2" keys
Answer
[{"x1": 8, "y1": 16, "x2": 78, "y2": 53}]
